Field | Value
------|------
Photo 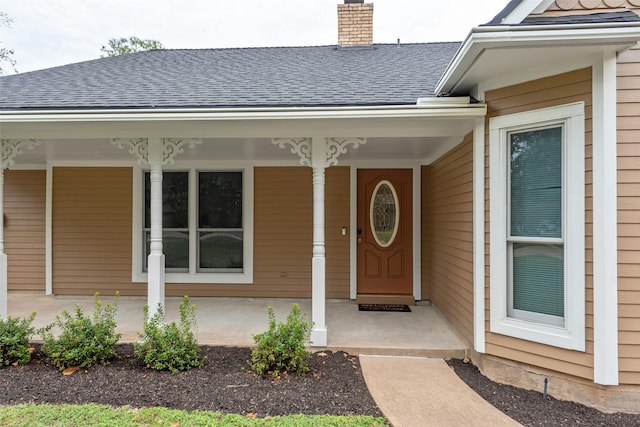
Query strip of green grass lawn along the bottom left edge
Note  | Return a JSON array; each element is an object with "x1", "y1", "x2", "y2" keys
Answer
[{"x1": 0, "y1": 404, "x2": 388, "y2": 427}]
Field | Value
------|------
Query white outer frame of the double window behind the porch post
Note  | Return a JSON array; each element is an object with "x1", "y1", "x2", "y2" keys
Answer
[{"x1": 132, "y1": 163, "x2": 253, "y2": 284}]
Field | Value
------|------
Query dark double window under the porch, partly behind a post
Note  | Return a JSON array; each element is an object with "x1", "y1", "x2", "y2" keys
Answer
[{"x1": 134, "y1": 168, "x2": 253, "y2": 283}]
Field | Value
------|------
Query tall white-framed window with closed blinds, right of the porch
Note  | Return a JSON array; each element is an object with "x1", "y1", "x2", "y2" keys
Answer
[{"x1": 490, "y1": 103, "x2": 585, "y2": 350}]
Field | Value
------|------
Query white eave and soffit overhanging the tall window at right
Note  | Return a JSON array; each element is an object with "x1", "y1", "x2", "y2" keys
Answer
[{"x1": 436, "y1": 23, "x2": 640, "y2": 95}]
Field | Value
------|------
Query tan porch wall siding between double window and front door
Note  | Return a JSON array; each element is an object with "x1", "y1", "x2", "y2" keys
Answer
[{"x1": 167, "y1": 167, "x2": 350, "y2": 298}]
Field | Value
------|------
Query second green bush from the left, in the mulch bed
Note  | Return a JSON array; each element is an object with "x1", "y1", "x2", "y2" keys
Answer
[{"x1": 38, "y1": 292, "x2": 121, "y2": 371}]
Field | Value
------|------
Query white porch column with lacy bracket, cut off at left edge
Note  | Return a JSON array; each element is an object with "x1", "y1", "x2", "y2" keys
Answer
[{"x1": 0, "y1": 139, "x2": 42, "y2": 319}]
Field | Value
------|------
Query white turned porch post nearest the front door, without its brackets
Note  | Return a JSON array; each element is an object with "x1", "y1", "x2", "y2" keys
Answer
[{"x1": 311, "y1": 138, "x2": 327, "y2": 347}]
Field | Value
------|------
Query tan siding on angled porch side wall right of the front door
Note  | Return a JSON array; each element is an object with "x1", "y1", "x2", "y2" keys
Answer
[{"x1": 423, "y1": 135, "x2": 473, "y2": 342}]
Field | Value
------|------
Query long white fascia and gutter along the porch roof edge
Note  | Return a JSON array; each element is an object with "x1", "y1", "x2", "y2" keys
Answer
[{"x1": 0, "y1": 102, "x2": 486, "y2": 123}]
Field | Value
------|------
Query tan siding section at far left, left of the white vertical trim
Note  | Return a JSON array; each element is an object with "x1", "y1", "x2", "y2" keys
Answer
[{"x1": 4, "y1": 170, "x2": 47, "y2": 292}]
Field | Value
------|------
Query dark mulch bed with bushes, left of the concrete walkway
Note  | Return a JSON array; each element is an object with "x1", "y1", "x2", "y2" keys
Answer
[{"x1": 0, "y1": 344, "x2": 382, "y2": 417}]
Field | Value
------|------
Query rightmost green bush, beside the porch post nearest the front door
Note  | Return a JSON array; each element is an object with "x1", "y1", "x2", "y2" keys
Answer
[{"x1": 251, "y1": 304, "x2": 312, "y2": 377}]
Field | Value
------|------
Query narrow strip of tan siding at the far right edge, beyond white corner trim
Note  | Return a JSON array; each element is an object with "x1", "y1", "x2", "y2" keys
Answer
[{"x1": 617, "y1": 36, "x2": 640, "y2": 384}]
